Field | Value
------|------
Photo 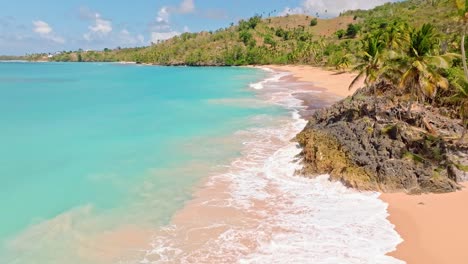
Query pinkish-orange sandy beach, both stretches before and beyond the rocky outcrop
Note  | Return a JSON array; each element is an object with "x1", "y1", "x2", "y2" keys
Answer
[{"x1": 266, "y1": 65, "x2": 468, "y2": 264}]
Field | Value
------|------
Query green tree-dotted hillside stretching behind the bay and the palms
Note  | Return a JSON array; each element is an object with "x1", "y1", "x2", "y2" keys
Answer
[{"x1": 31, "y1": 0, "x2": 460, "y2": 69}]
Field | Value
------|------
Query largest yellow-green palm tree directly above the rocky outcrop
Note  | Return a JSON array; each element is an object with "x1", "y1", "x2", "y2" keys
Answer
[{"x1": 400, "y1": 24, "x2": 456, "y2": 115}]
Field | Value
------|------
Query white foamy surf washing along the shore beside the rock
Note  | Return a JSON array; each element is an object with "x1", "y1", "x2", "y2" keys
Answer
[{"x1": 142, "y1": 67, "x2": 404, "y2": 264}]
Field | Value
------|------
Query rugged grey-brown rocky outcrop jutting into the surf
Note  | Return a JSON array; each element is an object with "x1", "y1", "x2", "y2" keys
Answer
[{"x1": 296, "y1": 91, "x2": 468, "y2": 193}]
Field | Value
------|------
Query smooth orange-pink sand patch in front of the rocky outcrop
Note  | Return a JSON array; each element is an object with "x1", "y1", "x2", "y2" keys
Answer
[{"x1": 381, "y1": 184, "x2": 468, "y2": 264}]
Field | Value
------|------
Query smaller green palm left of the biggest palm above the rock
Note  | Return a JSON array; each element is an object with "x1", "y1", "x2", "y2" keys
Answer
[{"x1": 349, "y1": 35, "x2": 385, "y2": 96}]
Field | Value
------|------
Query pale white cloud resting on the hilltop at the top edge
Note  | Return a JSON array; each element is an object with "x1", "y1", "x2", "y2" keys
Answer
[{"x1": 280, "y1": 0, "x2": 397, "y2": 16}]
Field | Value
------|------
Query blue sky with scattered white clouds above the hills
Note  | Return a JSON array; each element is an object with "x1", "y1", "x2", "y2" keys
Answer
[{"x1": 0, "y1": 0, "x2": 394, "y2": 55}]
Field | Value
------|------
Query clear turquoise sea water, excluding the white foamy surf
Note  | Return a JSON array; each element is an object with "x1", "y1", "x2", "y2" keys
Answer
[{"x1": 0, "y1": 63, "x2": 284, "y2": 264}]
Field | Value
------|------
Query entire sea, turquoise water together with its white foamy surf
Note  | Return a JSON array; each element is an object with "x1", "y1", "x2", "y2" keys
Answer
[{"x1": 0, "y1": 63, "x2": 401, "y2": 264}]
